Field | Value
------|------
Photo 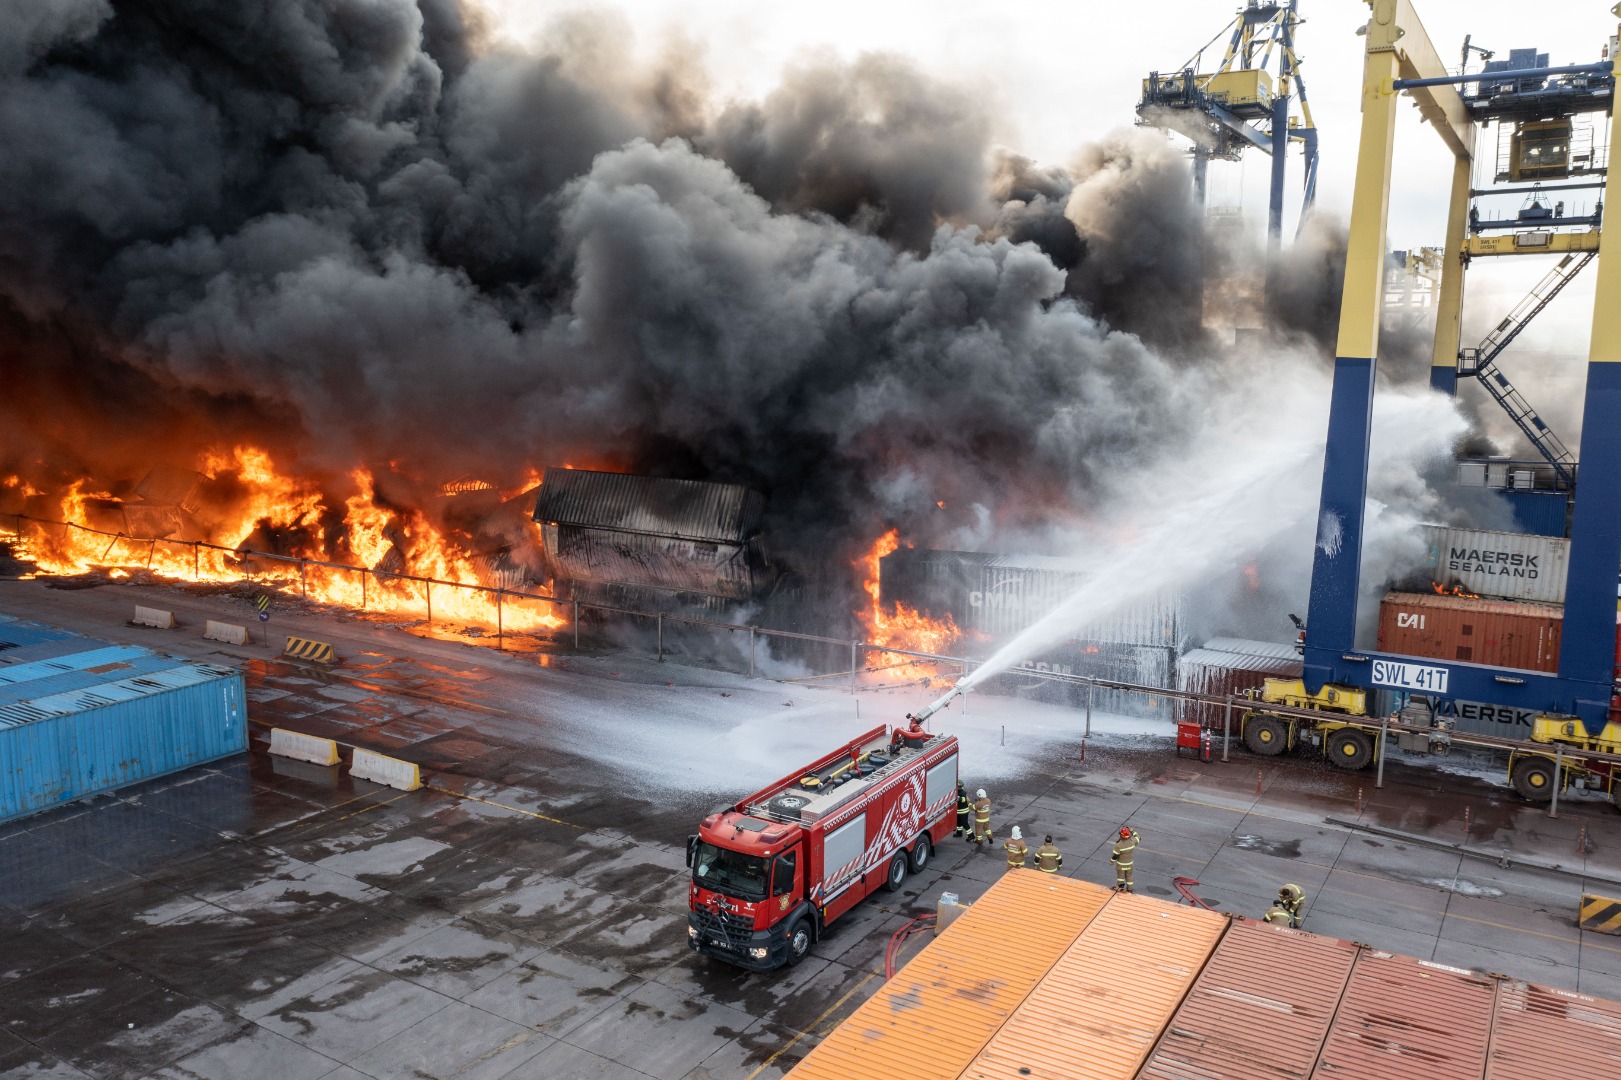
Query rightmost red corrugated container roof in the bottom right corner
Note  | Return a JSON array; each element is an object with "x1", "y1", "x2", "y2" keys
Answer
[{"x1": 1486, "y1": 979, "x2": 1621, "y2": 1080}]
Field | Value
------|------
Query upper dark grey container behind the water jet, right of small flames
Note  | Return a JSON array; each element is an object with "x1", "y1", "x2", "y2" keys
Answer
[{"x1": 879, "y1": 548, "x2": 1182, "y2": 649}]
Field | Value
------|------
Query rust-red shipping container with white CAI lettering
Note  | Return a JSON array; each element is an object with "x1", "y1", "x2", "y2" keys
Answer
[{"x1": 1378, "y1": 592, "x2": 1564, "y2": 671}]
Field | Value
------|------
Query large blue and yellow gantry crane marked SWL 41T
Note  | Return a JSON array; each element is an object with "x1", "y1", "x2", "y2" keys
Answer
[{"x1": 1303, "y1": 0, "x2": 1621, "y2": 735}]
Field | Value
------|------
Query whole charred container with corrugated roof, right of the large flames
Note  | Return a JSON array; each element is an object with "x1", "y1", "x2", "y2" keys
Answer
[{"x1": 535, "y1": 469, "x2": 768, "y2": 598}]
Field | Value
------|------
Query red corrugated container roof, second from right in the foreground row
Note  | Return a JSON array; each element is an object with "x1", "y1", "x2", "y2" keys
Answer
[{"x1": 1311, "y1": 950, "x2": 1491, "y2": 1080}]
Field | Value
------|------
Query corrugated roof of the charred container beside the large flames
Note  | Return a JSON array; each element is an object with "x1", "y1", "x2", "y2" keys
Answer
[{"x1": 535, "y1": 469, "x2": 765, "y2": 543}]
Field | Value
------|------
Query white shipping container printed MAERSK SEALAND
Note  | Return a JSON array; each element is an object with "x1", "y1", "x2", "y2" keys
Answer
[{"x1": 1420, "y1": 525, "x2": 1571, "y2": 603}]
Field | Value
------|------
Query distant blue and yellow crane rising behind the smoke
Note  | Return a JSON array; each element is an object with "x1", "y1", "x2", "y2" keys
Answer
[{"x1": 1136, "y1": 0, "x2": 1318, "y2": 250}]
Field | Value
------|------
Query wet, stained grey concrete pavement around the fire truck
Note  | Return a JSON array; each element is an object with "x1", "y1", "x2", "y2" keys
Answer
[{"x1": 0, "y1": 582, "x2": 1621, "y2": 1080}]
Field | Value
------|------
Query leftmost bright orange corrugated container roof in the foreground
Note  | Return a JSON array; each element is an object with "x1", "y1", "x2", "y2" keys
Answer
[{"x1": 789, "y1": 871, "x2": 1114, "y2": 1080}]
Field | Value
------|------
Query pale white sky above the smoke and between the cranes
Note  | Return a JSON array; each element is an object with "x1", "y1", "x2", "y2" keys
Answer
[{"x1": 488, "y1": 0, "x2": 1616, "y2": 248}]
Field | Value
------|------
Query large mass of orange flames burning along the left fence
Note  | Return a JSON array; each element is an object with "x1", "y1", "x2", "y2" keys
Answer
[{"x1": 9, "y1": 446, "x2": 566, "y2": 632}]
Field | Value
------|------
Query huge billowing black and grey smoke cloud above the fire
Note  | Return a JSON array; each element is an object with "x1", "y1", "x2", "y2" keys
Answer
[{"x1": 0, "y1": 0, "x2": 1270, "y2": 596}]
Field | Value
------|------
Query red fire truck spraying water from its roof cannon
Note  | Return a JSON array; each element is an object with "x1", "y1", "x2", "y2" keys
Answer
[{"x1": 687, "y1": 723, "x2": 956, "y2": 971}]
